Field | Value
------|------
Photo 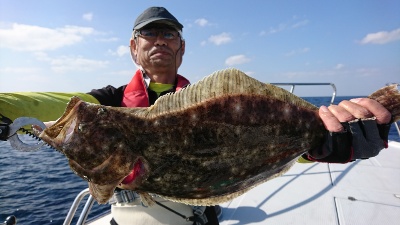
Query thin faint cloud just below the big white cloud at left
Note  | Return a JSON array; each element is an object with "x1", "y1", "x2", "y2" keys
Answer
[{"x1": 35, "y1": 52, "x2": 109, "y2": 73}]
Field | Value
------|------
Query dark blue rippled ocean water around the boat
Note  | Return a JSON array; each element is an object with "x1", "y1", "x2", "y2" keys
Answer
[{"x1": 0, "y1": 97, "x2": 400, "y2": 225}]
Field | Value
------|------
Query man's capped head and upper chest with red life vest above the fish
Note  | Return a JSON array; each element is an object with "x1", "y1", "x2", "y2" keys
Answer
[{"x1": 89, "y1": 7, "x2": 189, "y2": 107}]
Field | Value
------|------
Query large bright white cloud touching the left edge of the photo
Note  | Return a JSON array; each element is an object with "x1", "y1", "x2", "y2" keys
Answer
[{"x1": 0, "y1": 23, "x2": 95, "y2": 51}]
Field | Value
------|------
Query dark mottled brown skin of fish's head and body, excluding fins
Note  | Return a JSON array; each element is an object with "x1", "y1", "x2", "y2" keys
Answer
[{"x1": 42, "y1": 95, "x2": 324, "y2": 204}]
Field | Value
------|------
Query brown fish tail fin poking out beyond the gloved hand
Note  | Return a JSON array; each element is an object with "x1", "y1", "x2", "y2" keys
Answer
[{"x1": 368, "y1": 84, "x2": 400, "y2": 122}]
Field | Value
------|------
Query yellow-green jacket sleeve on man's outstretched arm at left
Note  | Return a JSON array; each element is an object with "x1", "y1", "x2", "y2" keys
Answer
[{"x1": 0, "y1": 92, "x2": 99, "y2": 121}]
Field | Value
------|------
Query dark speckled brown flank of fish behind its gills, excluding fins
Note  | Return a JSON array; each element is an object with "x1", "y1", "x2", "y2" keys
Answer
[{"x1": 127, "y1": 95, "x2": 324, "y2": 199}]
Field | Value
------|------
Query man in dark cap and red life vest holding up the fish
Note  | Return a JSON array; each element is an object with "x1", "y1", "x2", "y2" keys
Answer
[{"x1": 0, "y1": 7, "x2": 391, "y2": 225}]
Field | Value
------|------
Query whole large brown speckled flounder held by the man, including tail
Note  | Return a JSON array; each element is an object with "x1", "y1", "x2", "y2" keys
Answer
[{"x1": 40, "y1": 69, "x2": 400, "y2": 205}]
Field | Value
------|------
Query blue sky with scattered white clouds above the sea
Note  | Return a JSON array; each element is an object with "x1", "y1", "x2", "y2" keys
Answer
[{"x1": 0, "y1": 0, "x2": 400, "y2": 96}]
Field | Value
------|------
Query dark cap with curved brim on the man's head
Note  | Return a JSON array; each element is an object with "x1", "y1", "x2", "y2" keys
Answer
[{"x1": 133, "y1": 7, "x2": 183, "y2": 30}]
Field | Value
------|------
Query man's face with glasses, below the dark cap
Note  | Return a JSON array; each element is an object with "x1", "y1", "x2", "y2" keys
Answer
[{"x1": 131, "y1": 25, "x2": 185, "y2": 71}]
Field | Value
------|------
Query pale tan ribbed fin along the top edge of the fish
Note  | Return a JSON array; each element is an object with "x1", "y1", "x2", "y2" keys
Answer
[{"x1": 147, "y1": 69, "x2": 317, "y2": 117}]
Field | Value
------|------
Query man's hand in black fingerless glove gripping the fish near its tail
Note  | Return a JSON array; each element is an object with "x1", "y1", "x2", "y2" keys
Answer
[{"x1": 306, "y1": 98, "x2": 392, "y2": 163}]
